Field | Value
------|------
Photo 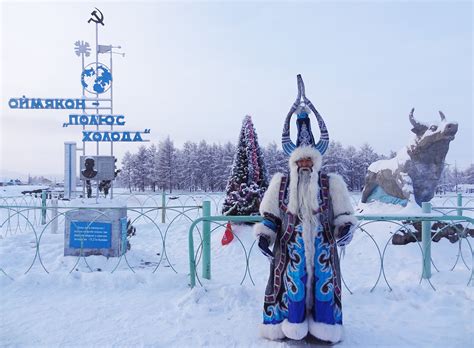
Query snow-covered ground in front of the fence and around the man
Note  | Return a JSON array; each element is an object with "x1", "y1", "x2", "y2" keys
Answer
[{"x1": 0, "y1": 188, "x2": 474, "y2": 347}]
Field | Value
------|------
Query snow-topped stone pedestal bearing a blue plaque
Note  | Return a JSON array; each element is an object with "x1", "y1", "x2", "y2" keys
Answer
[{"x1": 64, "y1": 199, "x2": 127, "y2": 257}]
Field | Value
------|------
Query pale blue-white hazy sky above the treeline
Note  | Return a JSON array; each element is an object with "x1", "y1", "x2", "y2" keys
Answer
[{"x1": 0, "y1": 1, "x2": 474, "y2": 178}]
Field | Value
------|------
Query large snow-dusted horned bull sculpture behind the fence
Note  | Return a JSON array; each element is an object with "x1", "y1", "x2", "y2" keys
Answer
[{"x1": 361, "y1": 109, "x2": 458, "y2": 206}]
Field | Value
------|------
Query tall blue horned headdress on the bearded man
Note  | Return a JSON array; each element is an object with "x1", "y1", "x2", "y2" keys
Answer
[{"x1": 281, "y1": 75, "x2": 329, "y2": 156}]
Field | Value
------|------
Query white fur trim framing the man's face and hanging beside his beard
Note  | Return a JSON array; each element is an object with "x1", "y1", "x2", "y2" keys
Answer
[{"x1": 288, "y1": 146, "x2": 322, "y2": 214}]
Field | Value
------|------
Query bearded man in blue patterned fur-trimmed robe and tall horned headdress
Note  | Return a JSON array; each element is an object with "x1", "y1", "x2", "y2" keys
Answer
[{"x1": 254, "y1": 75, "x2": 357, "y2": 343}]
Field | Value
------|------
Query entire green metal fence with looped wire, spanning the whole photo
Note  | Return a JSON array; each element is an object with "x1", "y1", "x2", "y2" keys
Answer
[{"x1": 0, "y1": 193, "x2": 474, "y2": 293}]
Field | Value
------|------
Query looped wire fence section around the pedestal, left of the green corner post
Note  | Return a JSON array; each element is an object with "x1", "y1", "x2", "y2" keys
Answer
[{"x1": 0, "y1": 197, "x2": 202, "y2": 278}]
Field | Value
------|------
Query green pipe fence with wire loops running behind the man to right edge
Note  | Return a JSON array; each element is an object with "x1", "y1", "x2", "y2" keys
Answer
[{"x1": 188, "y1": 203, "x2": 474, "y2": 293}]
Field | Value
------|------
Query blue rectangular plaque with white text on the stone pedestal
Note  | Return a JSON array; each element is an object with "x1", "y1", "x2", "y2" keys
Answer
[{"x1": 69, "y1": 221, "x2": 112, "y2": 249}]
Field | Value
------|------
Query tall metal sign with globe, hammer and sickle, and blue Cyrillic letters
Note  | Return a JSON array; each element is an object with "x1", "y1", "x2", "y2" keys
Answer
[{"x1": 8, "y1": 8, "x2": 150, "y2": 199}]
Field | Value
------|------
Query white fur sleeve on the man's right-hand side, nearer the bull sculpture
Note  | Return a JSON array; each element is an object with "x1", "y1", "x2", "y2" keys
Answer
[{"x1": 328, "y1": 173, "x2": 358, "y2": 231}]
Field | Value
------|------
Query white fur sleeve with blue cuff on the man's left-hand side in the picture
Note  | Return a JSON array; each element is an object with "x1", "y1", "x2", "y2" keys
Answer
[{"x1": 253, "y1": 173, "x2": 283, "y2": 245}]
